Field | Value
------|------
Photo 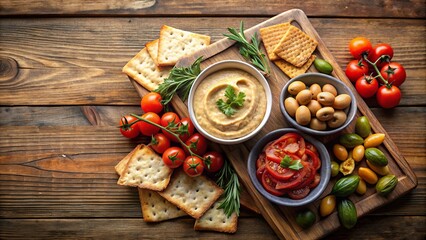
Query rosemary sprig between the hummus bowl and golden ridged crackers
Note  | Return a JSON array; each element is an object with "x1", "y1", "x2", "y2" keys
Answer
[{"x1": 223, "y1": 21, "x2": 271, "y2": 75}]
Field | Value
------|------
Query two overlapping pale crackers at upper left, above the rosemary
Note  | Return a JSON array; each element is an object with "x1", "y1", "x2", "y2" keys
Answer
[{"x1": 123, "y1": 25, "x2": 210, "y2": 91}]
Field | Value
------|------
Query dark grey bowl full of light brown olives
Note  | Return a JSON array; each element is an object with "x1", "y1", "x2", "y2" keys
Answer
[{"x1": 280, "y1": 73, "x2": 357, "y2": 136}]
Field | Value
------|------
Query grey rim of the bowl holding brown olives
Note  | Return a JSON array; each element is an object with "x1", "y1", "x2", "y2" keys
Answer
[{"x1": 280, "y1": 73, "x2": 358, "y2": 136}]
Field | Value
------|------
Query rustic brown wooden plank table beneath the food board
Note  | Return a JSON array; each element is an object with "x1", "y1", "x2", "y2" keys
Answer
[{"x1": 0, "y1": 0, "x2": 426, "y2": 239}]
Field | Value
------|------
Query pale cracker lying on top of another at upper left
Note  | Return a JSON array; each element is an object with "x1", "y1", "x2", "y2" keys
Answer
[{"x1": 157, "y1": 25, "x2": 210, "y2": 66}]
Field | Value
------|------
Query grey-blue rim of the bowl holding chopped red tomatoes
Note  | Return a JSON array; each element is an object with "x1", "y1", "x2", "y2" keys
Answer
[{"x1": 247, "y1": 128, "x2": 331, "y2": 207}]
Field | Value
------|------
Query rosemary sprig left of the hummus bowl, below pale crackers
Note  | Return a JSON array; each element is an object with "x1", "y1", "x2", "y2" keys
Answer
[{"x1": 154, "y1": 57, "x2": 203, "y2": 105}]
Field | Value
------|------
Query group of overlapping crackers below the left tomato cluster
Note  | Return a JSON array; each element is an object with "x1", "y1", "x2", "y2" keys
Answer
[{"x1": 115, "y1": 144, "x2": 237, "y2": 233}]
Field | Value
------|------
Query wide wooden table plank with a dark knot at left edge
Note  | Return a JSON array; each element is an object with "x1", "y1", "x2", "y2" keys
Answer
[{"x1": 0, "y1": 18, "x2": 426, "y2": 106}]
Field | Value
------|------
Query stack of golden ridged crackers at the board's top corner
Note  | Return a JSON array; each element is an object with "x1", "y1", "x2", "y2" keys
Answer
[{"x1": 260, "y1": 22, "x2": 318, "y2": 78}]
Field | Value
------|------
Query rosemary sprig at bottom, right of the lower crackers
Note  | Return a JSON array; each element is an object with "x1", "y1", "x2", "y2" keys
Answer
[{"x1": 216, "y1": 161, "x2": 240, "y2": 217}]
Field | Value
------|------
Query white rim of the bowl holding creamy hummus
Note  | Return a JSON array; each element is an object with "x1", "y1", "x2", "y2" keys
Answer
[{"x1": 188, "y1": 60, "x2": 272, "y2": 145}]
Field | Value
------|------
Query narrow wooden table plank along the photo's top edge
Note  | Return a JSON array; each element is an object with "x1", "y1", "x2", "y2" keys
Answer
[{"x1": 0, "y1": 0, "x2": 425, "y2": 18}]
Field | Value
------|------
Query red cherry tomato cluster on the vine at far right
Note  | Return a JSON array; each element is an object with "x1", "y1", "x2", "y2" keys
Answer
[{"x1": 345, "y1": 37, "x2": 406, "y2": 108}]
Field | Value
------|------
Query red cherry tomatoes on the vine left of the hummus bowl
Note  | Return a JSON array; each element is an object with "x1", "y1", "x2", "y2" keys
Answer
[{"x1": 120, "y1": 92, "x2": 224, "y2": 177}]
